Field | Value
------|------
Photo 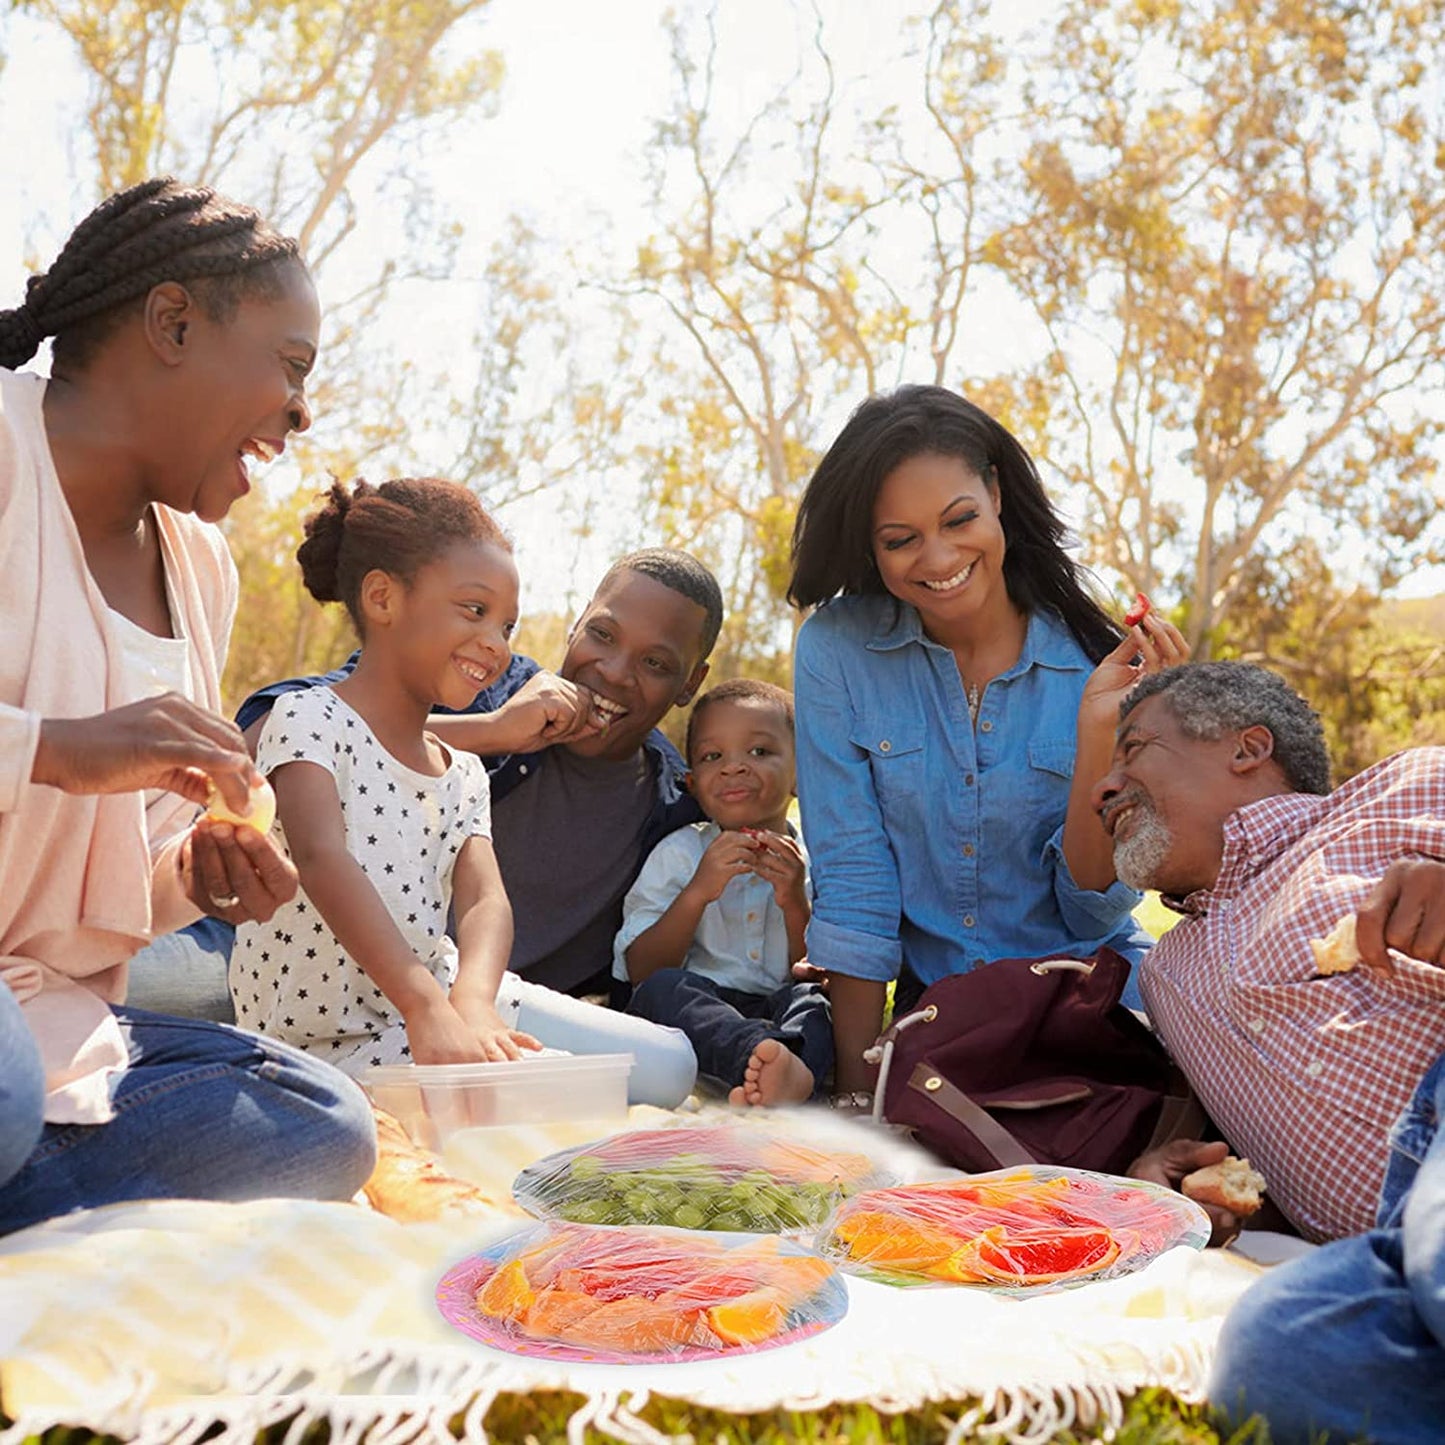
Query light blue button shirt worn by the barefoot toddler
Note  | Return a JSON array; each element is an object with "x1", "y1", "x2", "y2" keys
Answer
[{"x1": 613, "y1": 822, "x2": 808, "y2": 994}]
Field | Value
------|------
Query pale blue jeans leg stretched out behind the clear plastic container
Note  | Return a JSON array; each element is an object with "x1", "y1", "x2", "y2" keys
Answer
[{"x1": 497, "y1": 970, "x2": 698, "y2": 1108}]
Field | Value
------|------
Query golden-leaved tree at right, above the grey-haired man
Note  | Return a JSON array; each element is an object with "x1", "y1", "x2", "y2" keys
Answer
[{"x1": 954, "y1": 0, "x2": 1445, "y2": 655}]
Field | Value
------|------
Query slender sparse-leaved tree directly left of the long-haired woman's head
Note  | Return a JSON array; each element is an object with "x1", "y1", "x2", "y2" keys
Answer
[{"x1": 613, "y1": 10, "x2": 990, "y2": 675}]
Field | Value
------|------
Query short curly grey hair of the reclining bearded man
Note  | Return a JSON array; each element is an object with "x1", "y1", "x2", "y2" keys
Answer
[{"x1": 1118, "y1": 662, "x2": 1329, "y2": 793}]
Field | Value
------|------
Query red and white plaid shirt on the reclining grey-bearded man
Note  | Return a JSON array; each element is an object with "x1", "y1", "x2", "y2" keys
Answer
[{"x1": 1142, "y1": 747, "x2": 1445, "y2": 1240}]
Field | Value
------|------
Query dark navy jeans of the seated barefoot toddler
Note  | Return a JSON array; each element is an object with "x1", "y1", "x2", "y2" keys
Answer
[{"x1": 627, "y1": 968, "x2": 832, "y2": 1092}]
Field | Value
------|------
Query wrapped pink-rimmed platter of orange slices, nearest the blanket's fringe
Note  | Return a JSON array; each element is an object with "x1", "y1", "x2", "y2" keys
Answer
[{"x1": 436, "y1": 1222, "x2": 847, "y2": 1364}]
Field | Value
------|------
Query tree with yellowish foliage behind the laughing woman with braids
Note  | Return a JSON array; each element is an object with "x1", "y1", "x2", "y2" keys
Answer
[{"x1": 4, "y1": 0, "x2": 626, "y2": 696}]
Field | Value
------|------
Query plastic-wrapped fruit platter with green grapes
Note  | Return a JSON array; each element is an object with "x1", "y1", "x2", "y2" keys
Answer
[{"x1": 512, "y1": 1124, "x2": 893, "y2": 1234}]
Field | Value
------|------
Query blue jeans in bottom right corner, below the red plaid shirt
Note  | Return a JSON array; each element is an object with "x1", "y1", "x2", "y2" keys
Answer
[{"x1": 1209, "y1": 1058, "x2": 1445, "y2": 1445}]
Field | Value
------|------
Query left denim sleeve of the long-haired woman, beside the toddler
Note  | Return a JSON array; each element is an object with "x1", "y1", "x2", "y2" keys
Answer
[{"x1": 793, "y1": 616, "x2": 903, "y2": 981}]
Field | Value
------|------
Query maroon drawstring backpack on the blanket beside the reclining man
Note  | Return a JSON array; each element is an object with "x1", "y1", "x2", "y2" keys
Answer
[{"x1": 868, "y1": 948, "x2": 1204, "y2": 1173}]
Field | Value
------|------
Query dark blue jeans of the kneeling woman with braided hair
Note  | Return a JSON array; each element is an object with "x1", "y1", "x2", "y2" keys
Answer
[{"x1": 0, "y1": 1007, "x2": 376, "y2": 1234}]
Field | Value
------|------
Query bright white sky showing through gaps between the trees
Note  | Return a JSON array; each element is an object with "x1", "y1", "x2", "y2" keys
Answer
[{"x1": 0, "y1": 0, "x2": 1445, "y2": 610}]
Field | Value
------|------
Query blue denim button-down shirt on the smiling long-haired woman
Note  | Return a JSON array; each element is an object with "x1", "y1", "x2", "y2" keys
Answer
[{"x1": 793, "y1": 597, "x2": 1149, "y2": 984}]
